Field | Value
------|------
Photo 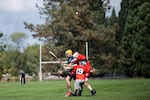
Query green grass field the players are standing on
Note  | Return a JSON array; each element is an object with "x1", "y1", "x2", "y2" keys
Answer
[{"x1": 0, "y1": 79, "x2": 150, "y2": 100}]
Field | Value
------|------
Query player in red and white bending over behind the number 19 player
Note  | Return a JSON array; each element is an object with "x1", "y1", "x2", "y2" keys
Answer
[{"x1": 65, "y1": 49, "x2": 96, "y2": 95}]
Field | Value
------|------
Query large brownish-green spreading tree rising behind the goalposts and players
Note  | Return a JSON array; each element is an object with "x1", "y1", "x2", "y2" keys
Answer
[{"x1": 24, "y1": 0, "x2": 109, "y2": 67}]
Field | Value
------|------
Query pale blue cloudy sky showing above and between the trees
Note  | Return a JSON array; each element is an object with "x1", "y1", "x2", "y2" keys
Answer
[{"x1": 0, "y1": 0, "x2": 121, "y2": 44}]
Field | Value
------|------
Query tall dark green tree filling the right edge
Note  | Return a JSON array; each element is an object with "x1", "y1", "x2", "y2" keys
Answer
[{"x1": 121, "y1": 0, "x2": 150, "y2": 76}]
